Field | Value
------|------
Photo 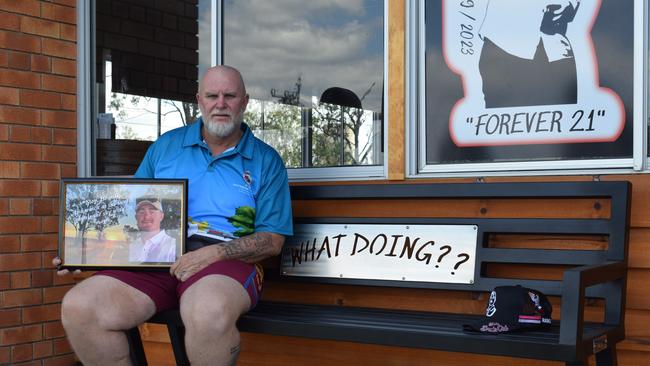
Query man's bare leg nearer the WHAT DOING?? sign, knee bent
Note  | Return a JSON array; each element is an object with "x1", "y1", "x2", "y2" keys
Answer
[{"x1": 180, "y1": 275, "x2": 251, "y2": 366}]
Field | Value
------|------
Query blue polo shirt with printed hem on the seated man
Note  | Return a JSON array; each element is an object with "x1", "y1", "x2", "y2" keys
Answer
[{"x1": 135, "y1": 118, "x2": 293, "y2": 239}]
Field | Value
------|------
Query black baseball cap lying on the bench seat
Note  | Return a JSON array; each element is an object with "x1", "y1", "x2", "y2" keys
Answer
[{"x1": 463, "y1": 286, "x2": 553, "y2": 333}]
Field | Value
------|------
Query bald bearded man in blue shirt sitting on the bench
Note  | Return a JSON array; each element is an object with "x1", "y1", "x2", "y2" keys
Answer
[{"x1": 53, "y1": 66, "x2": 292, "y2": 366}]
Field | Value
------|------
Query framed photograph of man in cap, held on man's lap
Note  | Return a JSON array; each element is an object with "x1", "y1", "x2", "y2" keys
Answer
[{"x1": 59, "y1": 178, "x2": 187, "y2": 269}]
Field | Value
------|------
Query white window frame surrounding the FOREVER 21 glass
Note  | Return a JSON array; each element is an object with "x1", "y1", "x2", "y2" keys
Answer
[{"x1": 406, "y1": 0, "x2": 650, "y2": 178}]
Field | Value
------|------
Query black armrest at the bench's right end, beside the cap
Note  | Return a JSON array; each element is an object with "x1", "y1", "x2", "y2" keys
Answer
[{"x1": 560, "y1": 261, "x2": 627, "y2": 344}]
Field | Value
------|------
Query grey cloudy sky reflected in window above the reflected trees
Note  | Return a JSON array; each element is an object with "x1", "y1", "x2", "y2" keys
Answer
[{"x1": 224, "y1": 0, "x2": 384, "y2": 111}]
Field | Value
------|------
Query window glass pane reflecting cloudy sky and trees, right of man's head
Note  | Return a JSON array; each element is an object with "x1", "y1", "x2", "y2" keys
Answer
[{"x1": 223, "y1": 0, "x2": 384, "y2": 168}]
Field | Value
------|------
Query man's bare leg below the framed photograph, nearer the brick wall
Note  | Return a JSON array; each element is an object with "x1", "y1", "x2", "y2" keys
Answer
[{"x1": 61, "y1": 276, "x2": 156, "y2": 366}]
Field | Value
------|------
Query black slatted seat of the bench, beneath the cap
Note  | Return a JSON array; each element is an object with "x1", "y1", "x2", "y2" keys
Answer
[{"x1": 238, "y1": 302, "x2": 614, "y2": 361}]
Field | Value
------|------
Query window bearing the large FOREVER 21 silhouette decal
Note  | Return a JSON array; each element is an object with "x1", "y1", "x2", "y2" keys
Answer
[{"x1": 409, "y1": 0, "x2": 647, "y2": 176}]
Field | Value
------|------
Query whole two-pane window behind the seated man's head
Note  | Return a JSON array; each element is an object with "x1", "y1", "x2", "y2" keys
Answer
[{"x1": 79, "y1": 0, "x2": 385, "y2": 179}]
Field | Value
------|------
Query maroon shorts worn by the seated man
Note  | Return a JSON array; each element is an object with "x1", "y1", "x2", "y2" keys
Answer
[{"x1": 95, "y1": 260, "x2": 264, "y2": 311}]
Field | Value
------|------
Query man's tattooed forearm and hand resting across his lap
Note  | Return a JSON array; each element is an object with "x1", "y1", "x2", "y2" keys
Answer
[{"x1": 169, "y1": 233, "x2": 284, "y2": 281}]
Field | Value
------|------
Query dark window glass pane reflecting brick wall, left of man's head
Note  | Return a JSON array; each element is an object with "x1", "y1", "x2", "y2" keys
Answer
[{"x1": 93, "y1": 0, "x2": 212, "y2": 175}]
